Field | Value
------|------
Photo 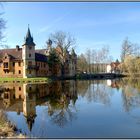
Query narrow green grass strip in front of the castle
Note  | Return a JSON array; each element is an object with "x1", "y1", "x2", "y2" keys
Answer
[{"x1": 0, "y1": 77, "x2": 51, "y2": 83}]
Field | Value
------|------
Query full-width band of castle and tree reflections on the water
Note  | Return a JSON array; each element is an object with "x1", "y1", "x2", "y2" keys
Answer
[{"x1": 0, "y1": 79, "x2": 140, "y2": 131}]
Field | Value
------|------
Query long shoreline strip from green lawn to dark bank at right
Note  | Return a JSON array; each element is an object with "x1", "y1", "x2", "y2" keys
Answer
[{"x1": 0, "y1": 73, "x2": 128, "y2": 83}]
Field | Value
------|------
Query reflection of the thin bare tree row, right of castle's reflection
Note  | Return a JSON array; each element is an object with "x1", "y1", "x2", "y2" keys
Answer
[{"x1": 77, "y1": 80, "x2": 113, "y2": 105}]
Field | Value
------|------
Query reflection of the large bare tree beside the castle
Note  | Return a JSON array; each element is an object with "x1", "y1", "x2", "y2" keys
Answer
[{"x1": 48, "y1": 81, "x2": 78, "y2": 127}]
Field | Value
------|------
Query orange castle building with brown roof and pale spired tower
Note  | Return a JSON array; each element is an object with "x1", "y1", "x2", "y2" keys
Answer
[{"x1": 0, "y1": 28, "x2": 77, "y2": 78}]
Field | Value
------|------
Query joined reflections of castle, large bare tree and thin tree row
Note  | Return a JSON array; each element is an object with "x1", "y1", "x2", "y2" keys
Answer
[{"x1": 0, "y1": 80, "x2": 120, "y2": 131}]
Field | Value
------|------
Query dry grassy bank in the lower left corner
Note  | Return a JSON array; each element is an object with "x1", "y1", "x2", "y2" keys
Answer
[{"x1": 0, "y1": 110, "x2": 25, "y2": 138}]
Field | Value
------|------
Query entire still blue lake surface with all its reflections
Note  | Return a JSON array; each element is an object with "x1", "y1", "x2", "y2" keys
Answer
[{"x1": 0, "y1": 79, "x2": 140, "y2": 138}]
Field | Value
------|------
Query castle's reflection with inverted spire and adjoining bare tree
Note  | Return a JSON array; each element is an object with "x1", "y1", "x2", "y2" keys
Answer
[{"x1": 0, "y1": 81, "x2": 78, "y2": 131}]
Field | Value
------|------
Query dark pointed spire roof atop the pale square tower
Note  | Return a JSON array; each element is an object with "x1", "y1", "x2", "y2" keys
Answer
[{"x1": 23, "y1": 26, "x2": 35, "y2": 46}]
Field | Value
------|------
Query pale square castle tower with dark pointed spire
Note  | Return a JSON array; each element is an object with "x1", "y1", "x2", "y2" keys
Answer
[{"x1": 22, "y1": 27, "x2": 36, "y2": 78}]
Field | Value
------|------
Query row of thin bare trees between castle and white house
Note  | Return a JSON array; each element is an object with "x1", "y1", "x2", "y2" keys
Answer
[{"x1": 77, "y1": 46, "x2": 113, "y2": 73}]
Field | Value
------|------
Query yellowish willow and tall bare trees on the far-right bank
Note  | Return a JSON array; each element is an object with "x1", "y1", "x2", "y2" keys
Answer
[{"x1": 119, "y1": 38, "x2": 140, "y2": 76}]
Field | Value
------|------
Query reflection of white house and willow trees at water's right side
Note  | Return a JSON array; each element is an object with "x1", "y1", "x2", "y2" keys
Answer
[{"x1": 107, "y1": 78, "x2": 140, "y2": 112}]
